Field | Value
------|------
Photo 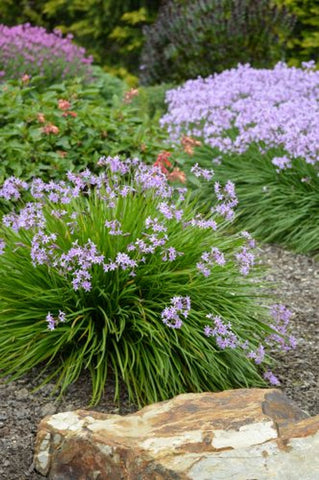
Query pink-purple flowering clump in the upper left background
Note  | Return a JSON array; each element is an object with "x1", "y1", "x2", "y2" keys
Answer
[{"x1": 0, "y1": 23, "x2": 93, "y2": 84}]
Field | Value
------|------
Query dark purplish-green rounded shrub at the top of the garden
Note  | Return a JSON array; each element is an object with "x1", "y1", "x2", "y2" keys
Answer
[{"x1": 140, "y1": 0, "x2": 293, "y2": 84}]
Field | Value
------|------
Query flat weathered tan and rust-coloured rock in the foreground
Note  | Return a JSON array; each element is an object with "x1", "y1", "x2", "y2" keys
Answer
[{"x1": 35, "y1": 389, "x2": 319, "y2": 480}]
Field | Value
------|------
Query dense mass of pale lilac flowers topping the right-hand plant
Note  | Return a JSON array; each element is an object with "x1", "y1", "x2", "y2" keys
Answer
[{"x1": 161, "y1": 63, "x2": 319, "y2": 171}]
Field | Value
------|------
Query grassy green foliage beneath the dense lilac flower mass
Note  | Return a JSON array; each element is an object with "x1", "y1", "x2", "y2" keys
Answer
[{"x1": 188, "y1": 145, "x2": 319, "y2": 256}]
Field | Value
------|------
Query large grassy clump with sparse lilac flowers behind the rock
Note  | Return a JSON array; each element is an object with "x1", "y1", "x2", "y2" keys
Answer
[{"x1": 0, "y1": 157, "x2": 293, "y2": 404}]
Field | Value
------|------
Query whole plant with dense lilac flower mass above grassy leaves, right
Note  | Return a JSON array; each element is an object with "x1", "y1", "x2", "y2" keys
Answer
[{"x1": 161, "y1": 62, "x2": 319, "y2": 254}]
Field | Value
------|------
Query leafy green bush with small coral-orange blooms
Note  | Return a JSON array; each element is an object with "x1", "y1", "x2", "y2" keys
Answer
[{"x1": 0, "y1": 76, "x2": 166, "y2": 180}]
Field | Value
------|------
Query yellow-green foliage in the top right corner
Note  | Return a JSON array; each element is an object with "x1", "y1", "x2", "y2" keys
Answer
[{"x1": 275, "y1": 0, "x2": 319, "y2": 65}]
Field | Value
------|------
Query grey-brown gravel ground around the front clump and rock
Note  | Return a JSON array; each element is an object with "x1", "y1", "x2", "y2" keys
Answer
[{"x1": 0, "y1": 246, "x2": 319, "y2": 480}]
